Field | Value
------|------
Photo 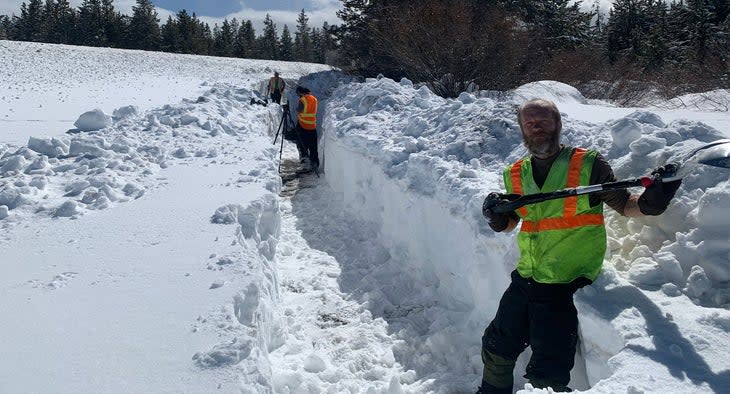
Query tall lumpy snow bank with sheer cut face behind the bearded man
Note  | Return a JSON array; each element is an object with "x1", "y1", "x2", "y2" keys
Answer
[{"x1": 324, "y1": 78, "x2": 728, "y2": 392}]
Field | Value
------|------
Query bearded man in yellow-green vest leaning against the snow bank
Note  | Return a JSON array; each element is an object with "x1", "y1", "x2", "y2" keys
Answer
[{"x1": 477, "y1": 99, "x2": 681, "y2": 394}]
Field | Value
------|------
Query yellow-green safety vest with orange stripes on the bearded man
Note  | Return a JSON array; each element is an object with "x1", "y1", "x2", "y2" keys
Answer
[{"x1": 504, "y1": 147, "x2": 606, "y2": 283}]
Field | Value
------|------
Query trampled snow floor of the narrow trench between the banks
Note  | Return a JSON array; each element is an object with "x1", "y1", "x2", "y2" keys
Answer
[{"x1": 270, "y1": 159, "x2": 413, "y2": 393}]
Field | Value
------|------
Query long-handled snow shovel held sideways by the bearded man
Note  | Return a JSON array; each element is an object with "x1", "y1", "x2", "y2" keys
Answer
[{"x1": 491, "y1": 139, "x2": 730, "y2": 213}]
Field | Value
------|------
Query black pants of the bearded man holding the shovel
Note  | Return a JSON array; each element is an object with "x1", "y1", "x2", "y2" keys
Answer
[{"x1": 482, "y1": 271, "x2": 590, "y2": 389}]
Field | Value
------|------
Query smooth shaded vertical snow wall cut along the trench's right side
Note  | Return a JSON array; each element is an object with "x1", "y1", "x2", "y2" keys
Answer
[{"x1": 326, "y1": 133, "x2": 604, "y2": 392}]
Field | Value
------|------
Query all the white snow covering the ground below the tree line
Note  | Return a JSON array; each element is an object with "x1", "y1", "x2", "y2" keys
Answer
[{"x1": 0, "y1": 41, "x2": 730, "y2": 394}]
